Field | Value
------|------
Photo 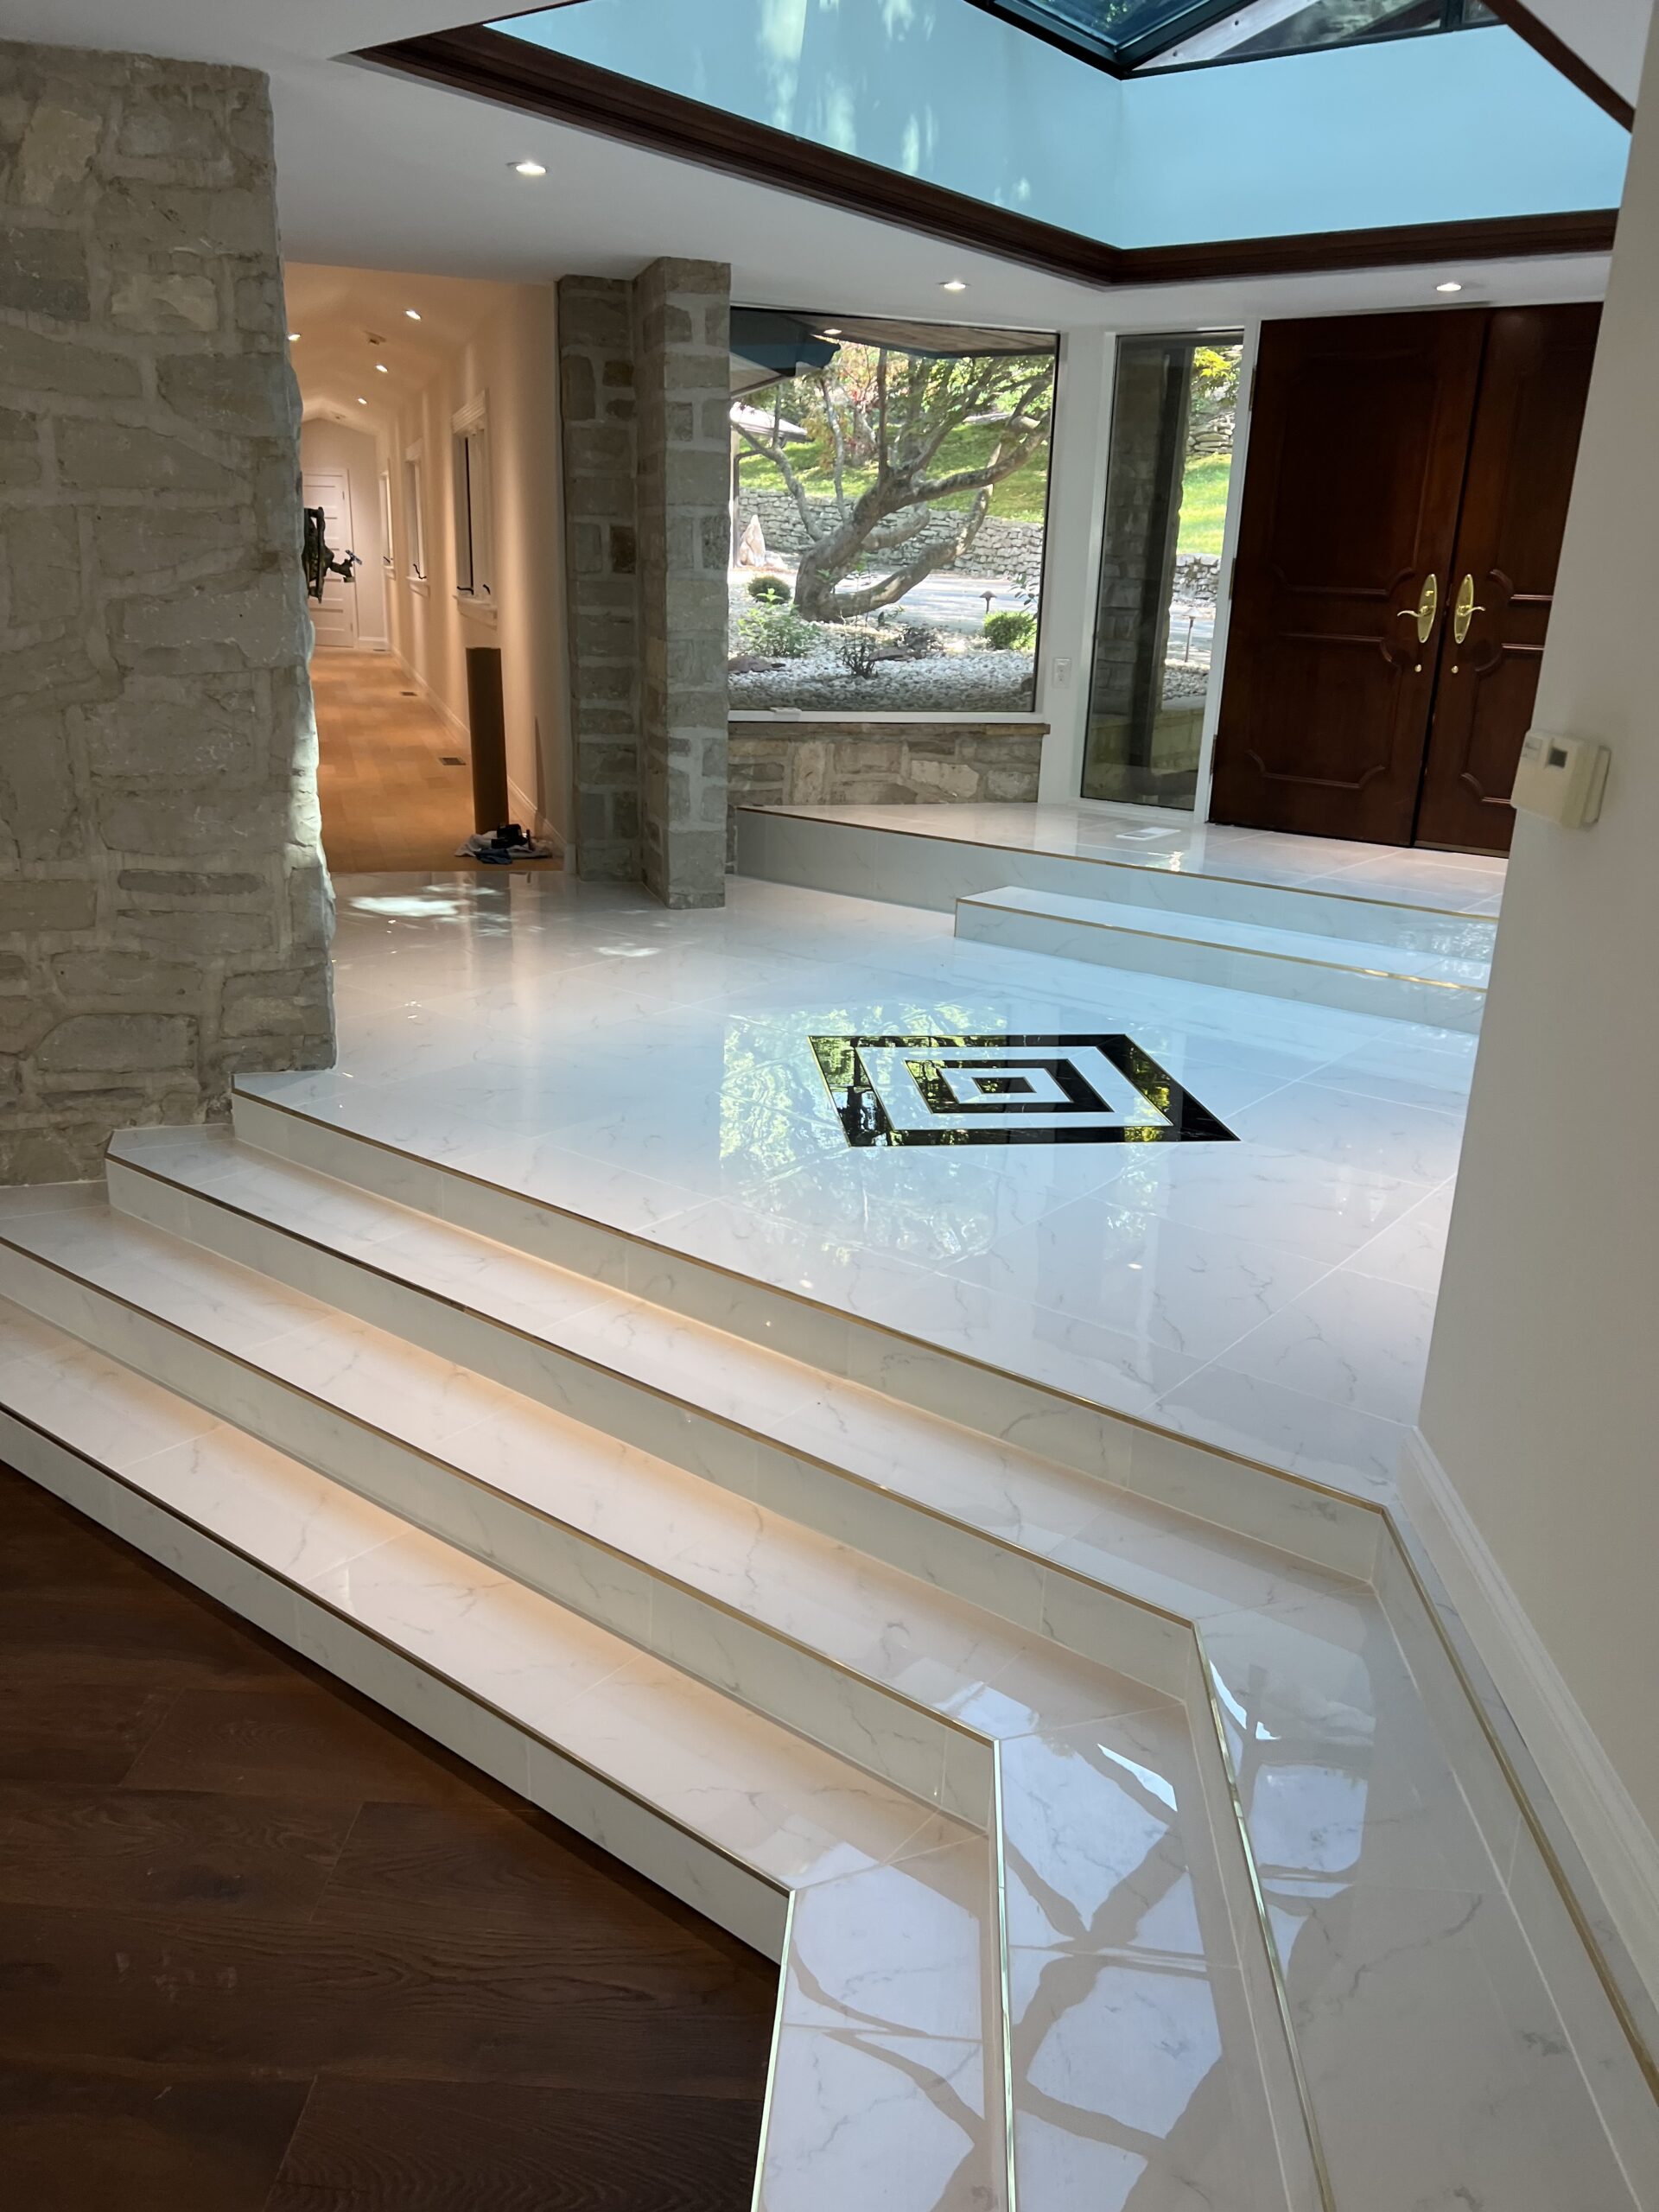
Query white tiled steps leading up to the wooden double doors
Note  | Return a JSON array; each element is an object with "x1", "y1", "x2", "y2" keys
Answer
[{"x1": 739, "y1": 807, "x2": 1497, "y2": 1031}]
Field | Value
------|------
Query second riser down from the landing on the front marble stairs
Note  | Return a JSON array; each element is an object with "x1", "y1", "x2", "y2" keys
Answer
[{"x1": 108, "y1": 1157, "x2": 1192, "y2": 1697}]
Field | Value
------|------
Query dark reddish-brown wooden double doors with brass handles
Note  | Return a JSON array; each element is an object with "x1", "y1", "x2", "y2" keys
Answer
[{"x1": 1210, "y1": 305, "x2": 1599, "y2": 852}]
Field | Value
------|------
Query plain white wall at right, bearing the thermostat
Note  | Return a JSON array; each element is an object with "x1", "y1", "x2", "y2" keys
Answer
[{"x1": 1409, "y1": 17, "x2": 1659, "y2": 1986}]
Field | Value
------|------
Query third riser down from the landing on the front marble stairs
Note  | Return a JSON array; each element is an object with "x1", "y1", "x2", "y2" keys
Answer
[{"x1": 0, "y1": 1252, "x2": 991, "y2": 1827}]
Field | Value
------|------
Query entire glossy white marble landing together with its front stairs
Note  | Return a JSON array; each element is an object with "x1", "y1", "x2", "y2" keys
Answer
[{"x1": 0, "y1": 858, "x2": 1659, "y2": 2212}]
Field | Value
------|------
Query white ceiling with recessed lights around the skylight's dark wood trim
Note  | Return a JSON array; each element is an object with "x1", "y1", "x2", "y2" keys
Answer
[{"x1": 0, "y1": 0, "x2": 1648, "y2": 327}]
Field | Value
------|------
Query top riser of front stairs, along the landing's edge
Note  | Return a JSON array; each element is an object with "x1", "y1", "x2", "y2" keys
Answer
[{"x1": 232, "y1": 1093, "x2": 1378, "y2": 1580}]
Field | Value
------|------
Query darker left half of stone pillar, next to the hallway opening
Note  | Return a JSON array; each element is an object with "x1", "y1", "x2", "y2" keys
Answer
[{"x1": 557, "y1": 276, "x2": 641, "y2": 882}]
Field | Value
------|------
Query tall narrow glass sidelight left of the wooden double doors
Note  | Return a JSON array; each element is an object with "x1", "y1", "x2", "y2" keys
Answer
[{"x1": 1084, "y1": 336, "x2": 1243, "y2": 807}]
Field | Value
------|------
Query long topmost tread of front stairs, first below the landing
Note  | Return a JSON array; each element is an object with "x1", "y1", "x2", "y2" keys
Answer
[{"x1": 111, "y1": 1128, "x2": 1343, "y2": 1619}]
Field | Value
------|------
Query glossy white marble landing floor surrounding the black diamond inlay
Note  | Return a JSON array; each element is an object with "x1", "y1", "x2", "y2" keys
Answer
[{"x1": 254, "y1": 876, "x2": 1476, "y2": 1493}]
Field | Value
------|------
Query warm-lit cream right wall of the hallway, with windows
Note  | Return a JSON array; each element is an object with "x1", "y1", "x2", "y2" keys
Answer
[{"x1": 390, "y1": 285, "x2": 569, "y2": 842}]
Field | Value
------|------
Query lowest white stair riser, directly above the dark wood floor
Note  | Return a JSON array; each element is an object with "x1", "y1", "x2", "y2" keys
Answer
[{"x1": 0, "y1": 1411, "x2": 787, "y2": 1960}]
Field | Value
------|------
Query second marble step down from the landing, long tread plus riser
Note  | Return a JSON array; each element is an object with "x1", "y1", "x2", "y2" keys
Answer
[{"x1": 0, "y1": 1210, "x2": 1188, "y2": 1827}]
